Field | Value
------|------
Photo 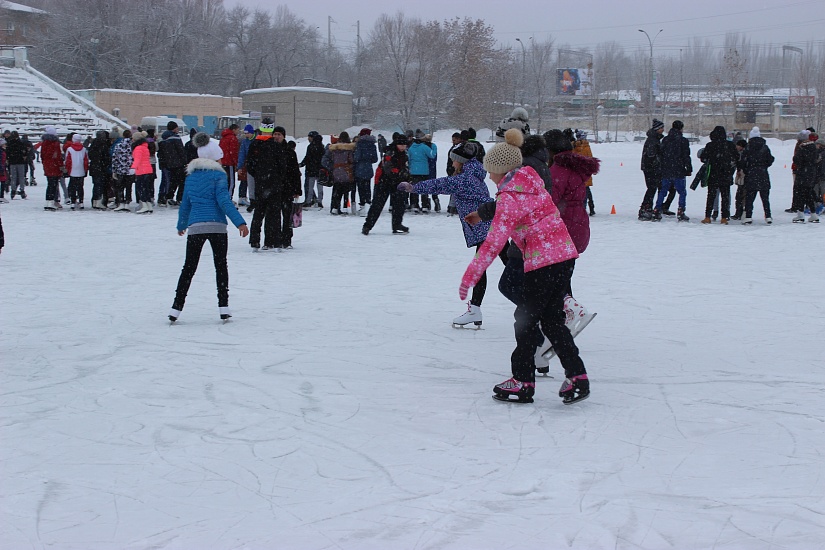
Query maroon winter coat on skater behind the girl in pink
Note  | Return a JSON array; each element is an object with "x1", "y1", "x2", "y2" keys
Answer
[{"x1": 550, "y1": 151, "x2": 600, "y2": 254}]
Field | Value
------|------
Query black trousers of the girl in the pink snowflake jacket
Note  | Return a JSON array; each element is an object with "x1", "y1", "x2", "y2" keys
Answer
[{"x1": 510, "y1": 260, "x2": 587, "y2": 382}]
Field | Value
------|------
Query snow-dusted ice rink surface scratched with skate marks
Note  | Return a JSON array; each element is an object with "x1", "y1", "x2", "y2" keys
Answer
[{"x1": 0, "y1": 141, "x2": 825, "y2": 550}]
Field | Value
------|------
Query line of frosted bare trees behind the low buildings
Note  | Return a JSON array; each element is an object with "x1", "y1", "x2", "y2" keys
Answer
[{"x1": 22, "y1": 0, "x2": 825, "y2": 130}]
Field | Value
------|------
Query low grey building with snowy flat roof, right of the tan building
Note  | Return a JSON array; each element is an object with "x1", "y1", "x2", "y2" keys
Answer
[{"x1": 241, "y1": 87, "x2": 352, "y2": 137}]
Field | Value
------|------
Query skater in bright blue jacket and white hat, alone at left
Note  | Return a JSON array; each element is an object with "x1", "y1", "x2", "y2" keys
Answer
[{"x1": 169, "y1": 133, "x2": 249, "y2": 323}]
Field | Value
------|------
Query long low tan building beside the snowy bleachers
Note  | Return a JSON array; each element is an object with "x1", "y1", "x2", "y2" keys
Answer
[{"x1": 75, "y1": 88, "x2": 241, "y2": 134}]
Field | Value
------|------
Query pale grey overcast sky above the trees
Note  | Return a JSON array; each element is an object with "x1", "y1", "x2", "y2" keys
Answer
[{"x1": 225, "y1": 0, "x2": 825, "y2": 53}]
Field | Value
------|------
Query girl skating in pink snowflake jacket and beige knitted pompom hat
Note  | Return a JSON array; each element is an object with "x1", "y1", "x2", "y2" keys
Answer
[{"x1": 459, "y1": 130, "x2": 590, "y2": 404}]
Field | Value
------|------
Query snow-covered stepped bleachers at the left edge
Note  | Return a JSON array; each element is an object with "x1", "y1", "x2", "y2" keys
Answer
[{"x1": 0, "y1": 47, "x2": 128, "y2": 136}]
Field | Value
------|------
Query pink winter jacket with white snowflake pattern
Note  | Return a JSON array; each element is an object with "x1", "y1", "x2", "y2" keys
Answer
[{"x1": 461, "y1": 166, "x2": 579, "y2": 287}]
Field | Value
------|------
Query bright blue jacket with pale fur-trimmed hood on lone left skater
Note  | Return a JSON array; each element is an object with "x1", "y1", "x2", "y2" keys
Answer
[{"x1": 178, "y1": 159, "x2": 246, "y2": 231}]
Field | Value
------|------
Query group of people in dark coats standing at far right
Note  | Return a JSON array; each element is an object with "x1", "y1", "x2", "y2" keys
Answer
[{"x1": 639, "y1": 119, "x2": 825, "y2": 225}]
